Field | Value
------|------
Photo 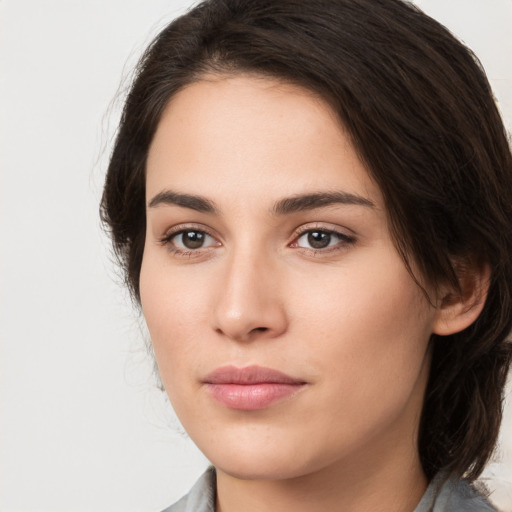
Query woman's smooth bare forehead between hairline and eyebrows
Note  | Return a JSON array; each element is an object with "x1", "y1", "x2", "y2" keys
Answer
[{"x1": 147, "y1": 76, "x2": 380, "y2": 208}]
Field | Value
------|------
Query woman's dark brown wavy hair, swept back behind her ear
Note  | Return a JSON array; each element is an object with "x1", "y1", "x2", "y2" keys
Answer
[{"x1": 101, "y1": 0, "x2": 512, "y2": 479}]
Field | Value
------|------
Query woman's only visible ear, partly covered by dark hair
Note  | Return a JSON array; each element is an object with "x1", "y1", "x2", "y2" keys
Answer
[{"x1": 433, "y1": 264, "x2": 491, "y2": 336}]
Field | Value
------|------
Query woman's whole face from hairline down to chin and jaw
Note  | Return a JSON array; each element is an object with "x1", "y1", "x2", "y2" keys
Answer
[{"x1": 140, "y1": 76, "x2": 436, "y2": 479}]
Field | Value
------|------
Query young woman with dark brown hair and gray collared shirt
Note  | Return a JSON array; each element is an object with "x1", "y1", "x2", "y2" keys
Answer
[{"x1": 102, "y1": 0, "x2": 512, "y2": 512}]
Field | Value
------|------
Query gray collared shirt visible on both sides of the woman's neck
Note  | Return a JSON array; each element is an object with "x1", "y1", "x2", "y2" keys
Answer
[{"x1": 162, "y1": 467, "x2": 496, "y2": 512}]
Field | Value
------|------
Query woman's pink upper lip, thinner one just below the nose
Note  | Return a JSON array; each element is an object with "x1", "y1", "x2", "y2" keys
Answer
[{"x1": 204, "y1": 365, "x2": 305, "y2": 385}]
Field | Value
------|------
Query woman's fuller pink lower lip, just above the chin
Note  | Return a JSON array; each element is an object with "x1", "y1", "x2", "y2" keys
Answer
[{"x1": 207, "y1": 382, "x2": 304, "y2": 411}]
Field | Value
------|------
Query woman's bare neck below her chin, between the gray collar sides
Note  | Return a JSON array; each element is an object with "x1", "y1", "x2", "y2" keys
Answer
[{"x1": 217, "y1": 445, "x2": 427, "y2": 512}]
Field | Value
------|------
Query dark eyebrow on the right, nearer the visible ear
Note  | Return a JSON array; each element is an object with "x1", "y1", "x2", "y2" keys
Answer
[{"x1": 272, "y1": 192, "x2": 375, "y2": 215}]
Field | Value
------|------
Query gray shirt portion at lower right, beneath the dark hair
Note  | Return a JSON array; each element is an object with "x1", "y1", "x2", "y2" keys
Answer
[{"x1": 414, "y1": 474, "x2": 497, "y2": 512}]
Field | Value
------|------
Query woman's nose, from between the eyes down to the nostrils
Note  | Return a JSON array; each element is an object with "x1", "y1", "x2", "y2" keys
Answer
[{"x1": 214, "y1": 247, "x2": 288, "y2": 342}]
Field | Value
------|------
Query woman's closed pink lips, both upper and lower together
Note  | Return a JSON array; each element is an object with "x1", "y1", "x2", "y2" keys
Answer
[{"x1": 203, "y1": 366, "x2": 306, "y2": 411}]
